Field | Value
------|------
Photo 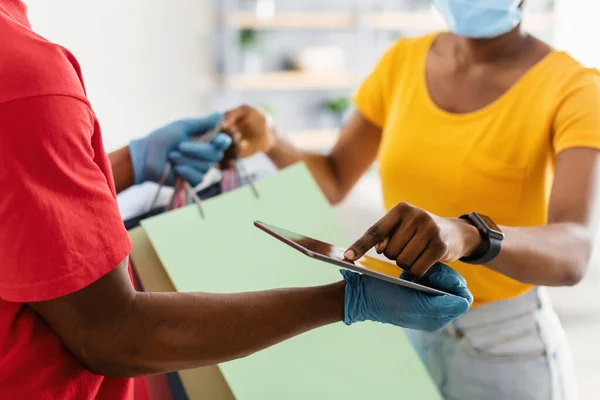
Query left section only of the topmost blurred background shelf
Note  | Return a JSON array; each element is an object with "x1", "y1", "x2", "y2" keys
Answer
[{"x1": 231, "y1": 12, "x2": 356, "y2": 29}]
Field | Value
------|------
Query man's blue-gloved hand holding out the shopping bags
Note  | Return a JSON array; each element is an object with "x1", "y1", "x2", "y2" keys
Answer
[{"x1": 129, "y1": 113, "x2": 231, "y2": 186}]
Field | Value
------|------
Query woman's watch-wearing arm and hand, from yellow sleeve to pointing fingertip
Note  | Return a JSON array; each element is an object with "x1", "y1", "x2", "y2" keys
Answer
[{"x1": 346, "y1": 148, "x2": 600, "y2": 286}]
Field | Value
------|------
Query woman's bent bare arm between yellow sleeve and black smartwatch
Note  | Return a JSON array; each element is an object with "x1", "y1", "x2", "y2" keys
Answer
[{"x1": 487, "y1": 148, "x2": 600, "y2": 286}]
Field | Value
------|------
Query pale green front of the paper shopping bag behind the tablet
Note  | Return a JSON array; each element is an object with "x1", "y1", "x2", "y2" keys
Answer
[{"x1": 142, "y1": 164, "x2": 441, "y2": 400}]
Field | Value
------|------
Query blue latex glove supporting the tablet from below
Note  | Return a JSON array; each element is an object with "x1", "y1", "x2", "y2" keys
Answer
[{"x1": 341, "y1": 263, "x2": 473, "y2": 332}]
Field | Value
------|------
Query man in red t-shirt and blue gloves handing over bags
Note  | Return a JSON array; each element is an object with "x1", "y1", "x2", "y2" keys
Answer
[{"x1": 0, "y1": 0, "x2": 472, "y2": 400}]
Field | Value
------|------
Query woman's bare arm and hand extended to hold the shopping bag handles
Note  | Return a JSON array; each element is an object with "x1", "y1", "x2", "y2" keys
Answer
[{"x1": 224, "y1": 106, "x2": 381, "y2": 204}]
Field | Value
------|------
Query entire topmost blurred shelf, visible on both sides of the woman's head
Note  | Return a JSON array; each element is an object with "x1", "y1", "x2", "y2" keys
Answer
[{"x1": 230, "y1": 11, "x2": 554, "y2": 31}]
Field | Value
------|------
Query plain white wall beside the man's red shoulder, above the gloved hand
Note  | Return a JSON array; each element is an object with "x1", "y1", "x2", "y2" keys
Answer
[{"x1": 26, "y1": 0, "x2": 212, "y2": 151}]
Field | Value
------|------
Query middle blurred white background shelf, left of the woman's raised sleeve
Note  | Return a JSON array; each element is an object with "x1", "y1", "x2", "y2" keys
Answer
[{"x1": 225, "y1": 71, "x2": 357, "y2": 90}]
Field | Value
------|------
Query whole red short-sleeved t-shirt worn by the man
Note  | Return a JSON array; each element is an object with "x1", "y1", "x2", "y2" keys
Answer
[{"x1": 0, "y1": 0, "x2": 134, "y2": 400}]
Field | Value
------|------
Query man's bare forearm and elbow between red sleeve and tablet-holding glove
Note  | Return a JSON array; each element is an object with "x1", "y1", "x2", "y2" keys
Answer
[{"x1": 29, "y1": 260, "x2": 346, "y2": 377}]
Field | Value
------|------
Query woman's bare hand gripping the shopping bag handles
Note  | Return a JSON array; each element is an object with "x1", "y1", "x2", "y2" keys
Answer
[{"x1": 222, "y1": 105, "x2": 276, "y2": 157}]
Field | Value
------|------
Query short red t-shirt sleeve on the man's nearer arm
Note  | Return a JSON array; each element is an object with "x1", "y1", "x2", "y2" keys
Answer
[{"x1": 0, "y1": 96, "x2": 131, "y2": 303}]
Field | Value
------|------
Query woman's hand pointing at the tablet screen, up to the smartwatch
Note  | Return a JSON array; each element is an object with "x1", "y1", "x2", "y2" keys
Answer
[{"x1": 345, "y1": 203, "x2": 482, "y2": 276}]
